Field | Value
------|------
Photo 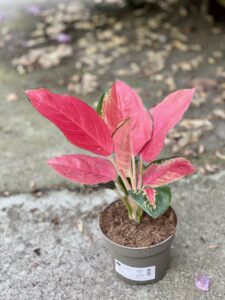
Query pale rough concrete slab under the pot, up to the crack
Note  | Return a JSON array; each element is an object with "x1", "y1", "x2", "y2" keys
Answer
[{"x1": 0, "y1": 172, "x2": 225, "y2": 300}]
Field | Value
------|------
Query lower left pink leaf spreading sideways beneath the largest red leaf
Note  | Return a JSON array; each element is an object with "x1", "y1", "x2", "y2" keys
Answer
[{"x1": 48, "y1": 154, "x2": 117, "y2": 184}]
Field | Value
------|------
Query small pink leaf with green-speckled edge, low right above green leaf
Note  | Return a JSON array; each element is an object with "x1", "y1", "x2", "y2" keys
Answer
[{"x1": 143, "y1": 157, "x2": 195, "y2": 187}]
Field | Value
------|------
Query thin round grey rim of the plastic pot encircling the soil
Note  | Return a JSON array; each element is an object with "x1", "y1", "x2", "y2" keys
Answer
[{"x1": 98, "y1": 199, "x2": 177, "y2": 250}]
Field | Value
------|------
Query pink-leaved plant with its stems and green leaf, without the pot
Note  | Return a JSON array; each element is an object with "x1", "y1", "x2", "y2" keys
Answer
[{"x1": 26, "y1": 80, "x2": 195, "y2": 223}]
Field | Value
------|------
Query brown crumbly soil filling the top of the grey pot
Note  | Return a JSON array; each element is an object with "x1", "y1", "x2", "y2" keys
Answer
[{"x1": 100, "y1": 200, "x2": 177, "y2": 248}]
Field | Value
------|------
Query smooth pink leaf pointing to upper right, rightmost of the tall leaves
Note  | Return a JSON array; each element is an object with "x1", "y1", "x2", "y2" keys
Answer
[{"x1": 141, "y1": 89, "x2": 195, "y2": 162}]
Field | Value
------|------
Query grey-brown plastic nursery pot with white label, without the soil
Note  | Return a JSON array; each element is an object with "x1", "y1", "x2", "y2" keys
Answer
[{"x1": 99, "y1": 200, "x2": 176, "y2": 284}]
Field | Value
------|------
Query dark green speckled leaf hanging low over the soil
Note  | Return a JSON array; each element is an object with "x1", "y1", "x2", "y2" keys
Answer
[{"x1": 129, "y1": 186, "x2": 171, "y2": 218}]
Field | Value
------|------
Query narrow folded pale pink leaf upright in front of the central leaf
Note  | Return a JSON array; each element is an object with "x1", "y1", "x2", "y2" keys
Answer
[{"x1": 112, "y1": 119, "x2": 131, "y2": 175}]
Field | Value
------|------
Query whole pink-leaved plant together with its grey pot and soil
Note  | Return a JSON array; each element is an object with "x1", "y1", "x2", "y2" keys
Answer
[{"x1": 26, "y1": 81, "x2": 195, "y2": 284}]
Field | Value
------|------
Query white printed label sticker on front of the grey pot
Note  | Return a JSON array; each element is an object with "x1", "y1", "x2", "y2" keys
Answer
[{"x1": 115, "y1": 259, "x2": 155, "y2": 281}]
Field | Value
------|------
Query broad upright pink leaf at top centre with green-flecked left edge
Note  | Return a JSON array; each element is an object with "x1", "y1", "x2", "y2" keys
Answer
[{"x1": 102, "y1": 80, "x2": 152, "y2": 155}]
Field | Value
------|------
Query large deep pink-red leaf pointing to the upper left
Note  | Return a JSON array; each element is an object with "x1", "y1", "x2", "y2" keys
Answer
[{"x1": 26, "y1": 89, "x2": 113, "y2": 156}]
